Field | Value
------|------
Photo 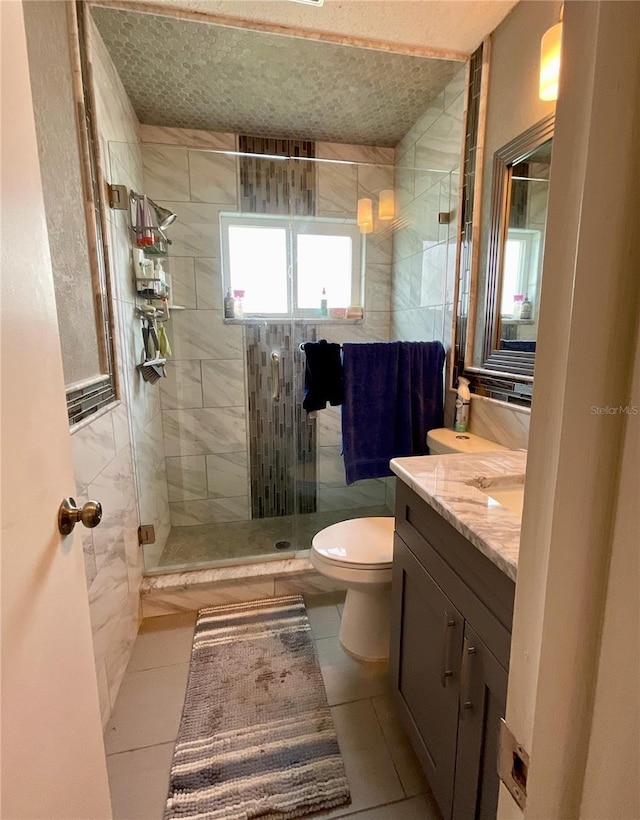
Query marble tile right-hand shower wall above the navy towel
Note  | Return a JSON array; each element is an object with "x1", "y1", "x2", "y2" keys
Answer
[{"x1": 391, "y1": 67, "x2": 466, "y2": 350}]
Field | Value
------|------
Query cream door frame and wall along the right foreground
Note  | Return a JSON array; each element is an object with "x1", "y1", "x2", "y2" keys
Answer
[{"x1": 499, "y1": 2, "x2": 640, "y2": 818}]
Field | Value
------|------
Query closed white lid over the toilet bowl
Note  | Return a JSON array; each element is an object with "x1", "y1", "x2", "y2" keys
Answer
[{"x1": 311, "y1": 518, "x2": 395, "y2": 566}]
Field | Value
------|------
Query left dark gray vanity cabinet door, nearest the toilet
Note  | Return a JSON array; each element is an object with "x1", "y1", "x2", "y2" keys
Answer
[{"x1": 390, "y1": 535, "x2": 464, "y2": 818}]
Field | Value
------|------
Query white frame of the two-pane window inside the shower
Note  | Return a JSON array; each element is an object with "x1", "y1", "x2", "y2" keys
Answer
[{"x1": 219, "y1": 212, "x2": 364, "y2": 322}]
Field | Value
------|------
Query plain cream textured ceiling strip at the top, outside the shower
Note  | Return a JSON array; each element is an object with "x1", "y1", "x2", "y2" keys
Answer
[{"x1": 102, "y1": 0, "x2": 517, "y2": 54}]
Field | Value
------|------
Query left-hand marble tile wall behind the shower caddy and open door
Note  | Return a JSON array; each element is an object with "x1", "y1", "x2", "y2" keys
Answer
[{"x1": 71, "y1": 17, "x2": 169, "y2": 724}]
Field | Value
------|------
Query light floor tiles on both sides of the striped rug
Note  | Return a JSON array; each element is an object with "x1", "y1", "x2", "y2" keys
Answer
[{"x1": 105, "y1": 595, "x2": 441, "y2": 820}]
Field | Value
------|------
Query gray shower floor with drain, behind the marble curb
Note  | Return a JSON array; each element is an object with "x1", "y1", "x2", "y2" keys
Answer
[{"x1": 145, "y1": 506, "x2": 391, "y2": 575}]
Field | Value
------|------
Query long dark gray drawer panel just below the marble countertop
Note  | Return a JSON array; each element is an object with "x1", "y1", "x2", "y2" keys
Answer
[{"x1": 396, "y1": 481, "x2": 515, "y2": 669}]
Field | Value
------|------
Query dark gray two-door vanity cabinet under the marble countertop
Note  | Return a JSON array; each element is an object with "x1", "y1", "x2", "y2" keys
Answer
[{"x1": 390, "y1": 481, "x2": 515, "y2": 820}]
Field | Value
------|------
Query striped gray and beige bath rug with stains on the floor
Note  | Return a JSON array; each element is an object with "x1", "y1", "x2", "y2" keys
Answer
[{"x1": 165, "y1": 595, "x2": 349, "y2": 820}]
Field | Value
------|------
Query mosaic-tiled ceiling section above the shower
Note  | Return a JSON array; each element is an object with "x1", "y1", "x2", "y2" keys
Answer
[{"x1": 92, "y1": 4, "x2": 462, "y2": 146}]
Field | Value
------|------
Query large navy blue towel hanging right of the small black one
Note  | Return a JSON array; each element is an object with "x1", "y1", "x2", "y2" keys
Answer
[{"x1": 342, "y1": 342, "x2": 445, "y2": 484}]
